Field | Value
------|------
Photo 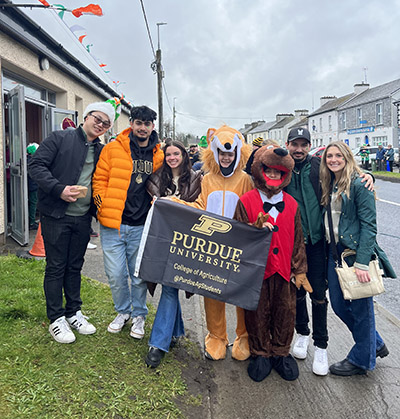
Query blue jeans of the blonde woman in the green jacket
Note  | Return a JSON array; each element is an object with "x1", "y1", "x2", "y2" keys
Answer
[{"x1": 328, "y1": 246, "x2": 384, "y2": 370}]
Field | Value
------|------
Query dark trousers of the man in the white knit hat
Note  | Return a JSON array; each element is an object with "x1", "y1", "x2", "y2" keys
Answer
[{"x1": 40, "y1": 214, "x2": 91, "y2": 322}]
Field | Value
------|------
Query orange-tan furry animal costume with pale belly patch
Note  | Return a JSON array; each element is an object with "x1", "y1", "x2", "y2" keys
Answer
[{"x1": 173, "y1": 125, "x2": 253, "y2": 361}]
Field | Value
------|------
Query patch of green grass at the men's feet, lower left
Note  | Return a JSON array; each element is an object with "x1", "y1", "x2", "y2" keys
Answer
[{"x1": 0, "y1": 256, "x2": 201, "y2": 419}]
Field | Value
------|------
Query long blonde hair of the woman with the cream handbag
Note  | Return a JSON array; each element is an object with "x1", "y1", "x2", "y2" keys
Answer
[{"x1": 319, "y1": 141, "x2": 362, "y2": 207}]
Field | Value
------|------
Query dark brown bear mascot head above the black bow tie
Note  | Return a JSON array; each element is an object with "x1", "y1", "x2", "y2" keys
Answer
[{"x1": 251, "y1": 145, "x2": 294, "y2": 198}]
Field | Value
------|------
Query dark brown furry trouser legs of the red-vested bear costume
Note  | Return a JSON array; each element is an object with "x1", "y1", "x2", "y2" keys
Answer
[{"x1": 244, "y1": 274, "x2": 296, "y2": 358}]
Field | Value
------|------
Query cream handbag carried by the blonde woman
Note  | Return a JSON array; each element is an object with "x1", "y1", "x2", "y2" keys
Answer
[{"x1": 335, "y1": 249, "x2": 385, "y2": 300}]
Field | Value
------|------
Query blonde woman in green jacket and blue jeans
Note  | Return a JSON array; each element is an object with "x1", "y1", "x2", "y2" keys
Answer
[{"x1": 320, "y1": 141, "x2": 396, "y2": 376}]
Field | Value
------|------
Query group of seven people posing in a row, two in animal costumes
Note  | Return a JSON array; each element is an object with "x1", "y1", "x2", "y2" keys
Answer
[{"x1": 29, "y1": 102, "x2": 395, "y2": 381}]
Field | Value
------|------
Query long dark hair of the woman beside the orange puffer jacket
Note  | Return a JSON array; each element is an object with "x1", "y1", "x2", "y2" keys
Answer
[{"x1": 160, "y1": 140, "x2": 192, "y2": 196}]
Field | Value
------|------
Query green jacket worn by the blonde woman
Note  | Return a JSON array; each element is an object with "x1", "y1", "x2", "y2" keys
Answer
[{"x1": 324, "y1": 176, "x2": 396, "y2": 278}]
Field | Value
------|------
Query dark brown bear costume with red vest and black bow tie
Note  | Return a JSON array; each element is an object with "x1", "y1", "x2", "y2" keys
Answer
[{"x1": 234, "y1": 145, "x2": 310, "y2": 381}]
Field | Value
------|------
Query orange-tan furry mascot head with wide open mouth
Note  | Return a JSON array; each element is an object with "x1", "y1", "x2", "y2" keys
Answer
[{"x1": 201, "y1": 125, "x2": 251, "y2": 177}]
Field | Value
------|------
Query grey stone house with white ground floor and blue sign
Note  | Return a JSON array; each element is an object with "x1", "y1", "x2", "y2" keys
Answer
[{"x1": 337, "y1": 79, "x2": 400, "y2": 148}]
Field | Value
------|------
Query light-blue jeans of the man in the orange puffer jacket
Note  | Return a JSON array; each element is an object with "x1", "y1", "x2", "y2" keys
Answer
[{"x1": 100, "y1": 224, "x2": 148, "y2": 317}]
